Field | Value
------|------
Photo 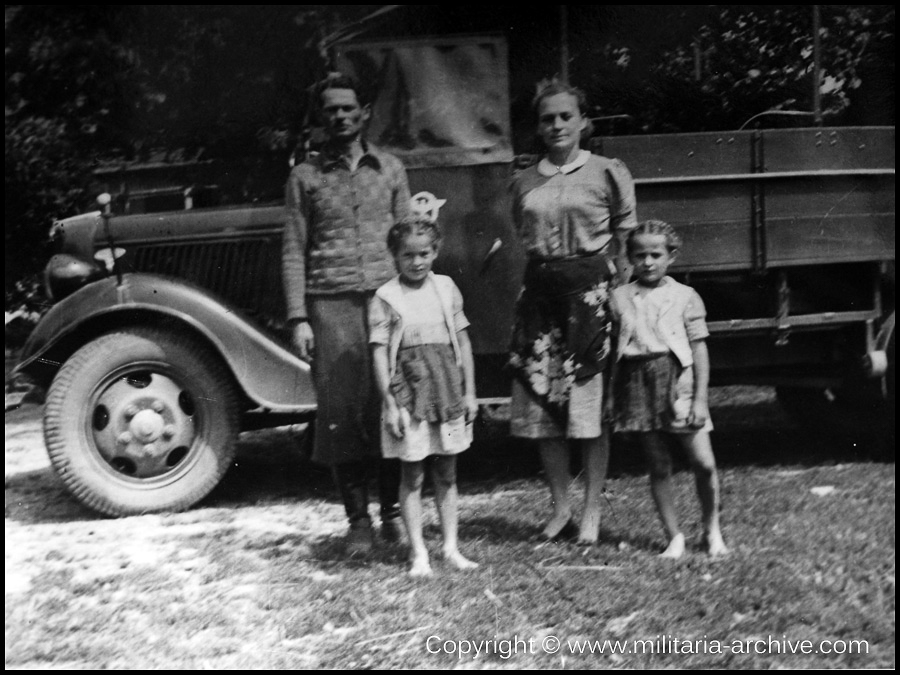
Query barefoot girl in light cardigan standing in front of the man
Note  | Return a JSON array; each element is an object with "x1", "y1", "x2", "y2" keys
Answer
[{"x1": 369, "y1": 215, "x2": 478, "y2": 577}]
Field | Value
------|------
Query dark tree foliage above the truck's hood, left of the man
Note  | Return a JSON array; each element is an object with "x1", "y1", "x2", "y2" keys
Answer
[{"x1": 5, "y1": 5, "x2": 334, "y2": 308}]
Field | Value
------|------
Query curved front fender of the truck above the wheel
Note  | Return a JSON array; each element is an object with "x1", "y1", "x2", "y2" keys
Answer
[{"x1": 16, "y1": 274, "x2": 316, "y2": 412}]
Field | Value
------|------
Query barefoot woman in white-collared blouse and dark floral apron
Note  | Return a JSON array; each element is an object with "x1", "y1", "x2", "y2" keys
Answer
[{"x1": 510, "y1": 81, "x2": 637, "y2": 545}]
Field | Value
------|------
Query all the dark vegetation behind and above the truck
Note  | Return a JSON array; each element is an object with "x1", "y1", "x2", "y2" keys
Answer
[{"x1": 5, "y1": 5, "x2": 895, "y2": 311}]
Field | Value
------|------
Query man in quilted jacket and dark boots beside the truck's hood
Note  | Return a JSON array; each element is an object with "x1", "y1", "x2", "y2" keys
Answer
[{"x1": 283, "y1": 73, "x2": 410, "y2": 555}]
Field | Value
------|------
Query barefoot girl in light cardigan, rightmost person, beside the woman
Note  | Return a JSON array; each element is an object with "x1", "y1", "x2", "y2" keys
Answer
[{"x1": 610, "y1": 220, "x2": 728, "y2": 558}]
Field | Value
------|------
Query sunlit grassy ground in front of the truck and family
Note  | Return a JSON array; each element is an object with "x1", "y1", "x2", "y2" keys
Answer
[{"x1": 6, "y1": 390, "x2": 895, "y2": 669}]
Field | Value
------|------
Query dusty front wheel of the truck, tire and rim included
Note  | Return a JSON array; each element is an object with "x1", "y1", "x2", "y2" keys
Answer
[{"x1": 44, "y1": 328, "x2": 237, "y2": 516}]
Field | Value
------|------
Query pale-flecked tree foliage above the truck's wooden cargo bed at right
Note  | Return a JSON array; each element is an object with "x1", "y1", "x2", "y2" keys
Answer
[{"x1": 642, "y1": 5, "x2": 894, "y2": 131}]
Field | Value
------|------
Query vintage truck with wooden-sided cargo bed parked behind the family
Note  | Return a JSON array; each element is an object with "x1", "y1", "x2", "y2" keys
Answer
[{"x1": 18, "y1": 36, "x2": 894, "y2": 515}]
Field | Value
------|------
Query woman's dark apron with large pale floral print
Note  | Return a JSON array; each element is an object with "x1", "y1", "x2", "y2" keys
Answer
[{"x1": 509, "y1": 254, "x2": 613, "y2": 435}]
